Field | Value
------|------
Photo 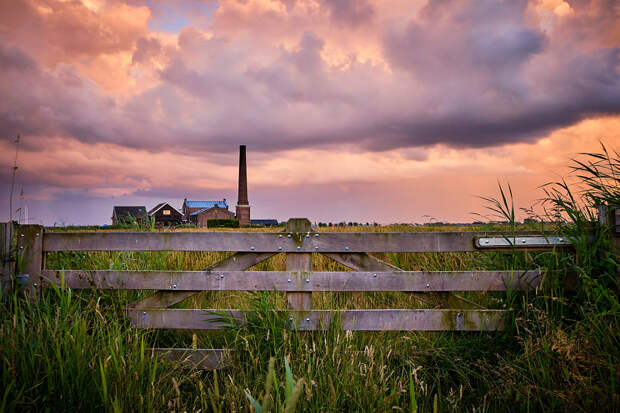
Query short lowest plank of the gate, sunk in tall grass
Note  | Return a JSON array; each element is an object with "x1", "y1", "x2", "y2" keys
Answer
[{"x1": 151, "y1": 348, "x2": 230, "y2": 370}]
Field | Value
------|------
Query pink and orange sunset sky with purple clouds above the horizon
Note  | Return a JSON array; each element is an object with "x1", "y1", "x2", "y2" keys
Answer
[{"x1": 0, "y1": 0, "x2": 620, "y2": 225}]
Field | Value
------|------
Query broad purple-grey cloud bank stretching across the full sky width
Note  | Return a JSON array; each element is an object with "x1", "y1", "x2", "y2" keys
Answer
[{"x1": 0, "y1": 1, "x2": 620, "y2": 153}]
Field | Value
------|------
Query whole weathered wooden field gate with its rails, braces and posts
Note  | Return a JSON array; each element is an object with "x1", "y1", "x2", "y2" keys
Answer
[{"x1": 0, "y1": 215, "x2": 618, "y2": 368}]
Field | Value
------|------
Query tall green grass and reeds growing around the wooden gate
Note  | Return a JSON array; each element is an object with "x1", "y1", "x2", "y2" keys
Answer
[{"x1": 0, "y1": 145, "x2": 620, "y2": 412}]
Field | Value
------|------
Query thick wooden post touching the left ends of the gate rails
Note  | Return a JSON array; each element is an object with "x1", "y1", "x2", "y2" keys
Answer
[{"x1": 17, "y1": 225, "x2": 43, "y2": 298}]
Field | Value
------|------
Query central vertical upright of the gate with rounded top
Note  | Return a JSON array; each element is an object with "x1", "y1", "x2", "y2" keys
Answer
[{"x1": 286, "y1": 218, "x2": 312, "y2": 310}]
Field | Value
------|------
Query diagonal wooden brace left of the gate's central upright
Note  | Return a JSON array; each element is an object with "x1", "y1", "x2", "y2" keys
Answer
[{"x1": 130, "y1": 252, "x2": 275, "y2": 308}]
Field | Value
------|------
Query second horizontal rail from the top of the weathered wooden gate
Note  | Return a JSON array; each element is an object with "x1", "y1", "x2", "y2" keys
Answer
[{"x1": 43, "y1": 270, "x2": 541, "y2": 292}]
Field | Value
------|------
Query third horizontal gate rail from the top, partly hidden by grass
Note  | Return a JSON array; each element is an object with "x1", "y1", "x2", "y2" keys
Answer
[{"x1": 128, "y1": 309, "x2": 506, "y2": 331}]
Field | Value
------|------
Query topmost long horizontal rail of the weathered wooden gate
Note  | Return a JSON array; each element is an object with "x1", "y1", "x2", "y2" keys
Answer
[{"x1": 43, "y1": 232, "x2": 568, "y2": 253}]
